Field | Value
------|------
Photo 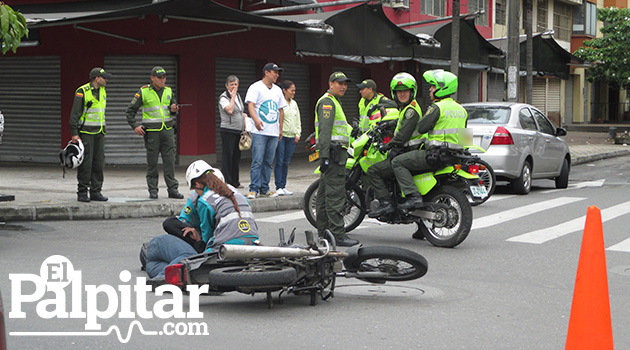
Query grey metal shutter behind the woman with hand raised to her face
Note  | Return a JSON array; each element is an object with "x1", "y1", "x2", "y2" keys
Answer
[{"x1": 215, "y1": 58, "x2": 262, "y2": 161}]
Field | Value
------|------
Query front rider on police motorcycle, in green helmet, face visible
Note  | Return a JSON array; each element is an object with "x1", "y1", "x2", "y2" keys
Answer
[{"x1": 367, "y1": 73, "x2": 424, "y2": 218}]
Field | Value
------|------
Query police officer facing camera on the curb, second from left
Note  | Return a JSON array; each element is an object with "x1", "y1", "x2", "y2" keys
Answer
[{"x1": 127, "y1": 66, "x2": 184, "y2": 199}]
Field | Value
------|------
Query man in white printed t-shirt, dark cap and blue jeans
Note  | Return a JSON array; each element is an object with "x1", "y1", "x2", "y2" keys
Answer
[{"x1": 245, "y1": 63, "x2": 287, "y2": 199}]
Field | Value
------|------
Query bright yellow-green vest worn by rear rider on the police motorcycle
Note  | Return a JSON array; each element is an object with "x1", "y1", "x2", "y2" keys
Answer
[{"x1": 427, "y1": 98, "x2": 468, "y2": 149}]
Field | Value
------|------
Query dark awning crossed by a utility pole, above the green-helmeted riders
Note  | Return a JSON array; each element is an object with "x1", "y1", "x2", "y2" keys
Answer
[{"x1": 406, "y1": 19, "x2": 503, "y2": 70}]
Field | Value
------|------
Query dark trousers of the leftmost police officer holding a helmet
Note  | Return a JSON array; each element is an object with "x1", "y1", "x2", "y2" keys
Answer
[{"x1": 77, "y1": 133, "x2": 105, "y2": 194}]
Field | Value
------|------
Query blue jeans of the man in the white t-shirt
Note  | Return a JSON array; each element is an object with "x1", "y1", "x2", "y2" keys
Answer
[{"x1": 249, "y1": 134, "x2": 278, "y2": 194}]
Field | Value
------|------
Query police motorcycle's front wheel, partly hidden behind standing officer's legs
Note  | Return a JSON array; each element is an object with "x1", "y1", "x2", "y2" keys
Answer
[{"x1": 304, "y1": 179, "x2": 366, "y2": 232}]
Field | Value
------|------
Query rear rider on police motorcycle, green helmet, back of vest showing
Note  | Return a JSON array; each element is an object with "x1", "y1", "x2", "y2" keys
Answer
[{"x1": 392, "y1": 69, "x2": 468, "y2": 209}]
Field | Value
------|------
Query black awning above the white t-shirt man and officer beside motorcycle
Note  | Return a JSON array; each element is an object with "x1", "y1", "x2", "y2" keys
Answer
[{"x1": 271, "y1": 3, "x2": 434, "y2": 63}]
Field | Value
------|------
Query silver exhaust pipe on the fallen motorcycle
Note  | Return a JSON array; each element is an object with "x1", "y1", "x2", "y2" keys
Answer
[{"x1": 219, "y1": 244, "x2": 322, "y2": 260}]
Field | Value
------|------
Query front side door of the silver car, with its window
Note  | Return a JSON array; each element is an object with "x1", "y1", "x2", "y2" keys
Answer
[{"x1": 532, "y1": 108, "x2": 564, "y2": 176}]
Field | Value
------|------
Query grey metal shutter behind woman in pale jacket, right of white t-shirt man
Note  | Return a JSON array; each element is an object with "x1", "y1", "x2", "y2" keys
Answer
[{"x1": 278, "y1": 63, "x2": 315, "y2": 153}]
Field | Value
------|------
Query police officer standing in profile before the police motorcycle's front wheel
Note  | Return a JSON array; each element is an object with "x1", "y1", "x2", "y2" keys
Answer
[{"x1": 315, "y1": 72, "x2": 359, "y2": 247}]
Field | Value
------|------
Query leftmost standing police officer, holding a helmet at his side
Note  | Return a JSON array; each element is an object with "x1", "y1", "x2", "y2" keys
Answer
[{"x1": 70, "y1": 67, "x2": 112, "y2": 202}]
